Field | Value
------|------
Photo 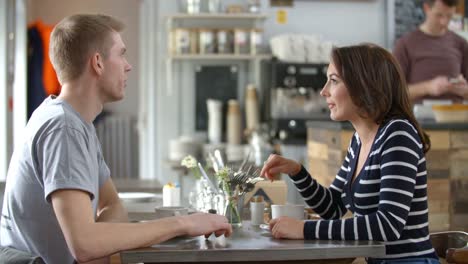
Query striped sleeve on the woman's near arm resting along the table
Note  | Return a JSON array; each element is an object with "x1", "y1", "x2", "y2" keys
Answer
[{"x1": 304, "y1": 121, "x2": 424, "y2": 241}]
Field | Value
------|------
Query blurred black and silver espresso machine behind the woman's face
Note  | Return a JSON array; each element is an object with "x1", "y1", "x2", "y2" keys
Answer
[{"x1": 262, "y1": 59, "x2": 330, "y2": 145}]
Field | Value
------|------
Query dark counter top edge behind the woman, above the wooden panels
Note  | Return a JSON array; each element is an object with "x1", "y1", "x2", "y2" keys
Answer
[{"x1": 306, "y1": 120, "x2": 468, "y2": 130}]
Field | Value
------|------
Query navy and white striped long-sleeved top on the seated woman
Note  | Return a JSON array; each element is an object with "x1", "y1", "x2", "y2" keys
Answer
[{"x1": 291, "y1": 119, "x2": 437, "y2": 259}]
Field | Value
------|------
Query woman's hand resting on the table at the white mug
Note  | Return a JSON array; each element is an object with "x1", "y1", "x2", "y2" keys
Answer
[{"x1": 270, "y1": 216, "x2": 304, "y2": 239}]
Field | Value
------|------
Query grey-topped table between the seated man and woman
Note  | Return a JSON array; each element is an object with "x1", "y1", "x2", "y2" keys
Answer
[{"x1": 120, "y1": 222, "x2": 385, "y2": 264}]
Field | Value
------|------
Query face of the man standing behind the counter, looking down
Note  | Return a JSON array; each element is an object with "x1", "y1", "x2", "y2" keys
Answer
[{"x1": 424, "y1": 0, "x2": 456, "y2": 35}]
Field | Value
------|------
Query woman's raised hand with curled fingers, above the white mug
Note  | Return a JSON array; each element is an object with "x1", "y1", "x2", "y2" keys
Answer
[{"x1": 260, "y1": 154, "x2": 301, "y2": 180}]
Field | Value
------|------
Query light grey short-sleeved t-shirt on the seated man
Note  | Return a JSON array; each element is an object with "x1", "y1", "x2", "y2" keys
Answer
[{"x1": 0, "y1": 97, "x2": 110, "y2": 264}]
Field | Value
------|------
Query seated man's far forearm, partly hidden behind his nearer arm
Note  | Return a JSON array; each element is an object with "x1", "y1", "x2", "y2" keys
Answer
[{"x1": 96, "y1": 178, "x2": 128, "y2": 222}]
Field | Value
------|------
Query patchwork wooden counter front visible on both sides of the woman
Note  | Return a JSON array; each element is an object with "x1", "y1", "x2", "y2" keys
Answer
[{"x1": 307, "y1": 121, "x2": 468, "y2": 232}]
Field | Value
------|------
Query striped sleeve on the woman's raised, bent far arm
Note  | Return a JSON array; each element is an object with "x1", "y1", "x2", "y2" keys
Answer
[{"x1": 290, "y1": 137, "x2": 353, "y2": 219}]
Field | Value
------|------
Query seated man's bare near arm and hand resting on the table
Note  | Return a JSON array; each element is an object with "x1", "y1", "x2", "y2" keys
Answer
[{"x1": 51, "y1": 189, "x2": 232, "y2": 262}]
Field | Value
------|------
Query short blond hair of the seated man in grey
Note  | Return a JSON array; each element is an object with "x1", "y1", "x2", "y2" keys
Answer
[{"x1": 49, "y1": 14, "x2": 124, "y2": 84}]
